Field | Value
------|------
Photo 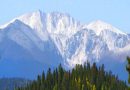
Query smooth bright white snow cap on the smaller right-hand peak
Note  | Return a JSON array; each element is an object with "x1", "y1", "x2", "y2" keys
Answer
[{"x1": 87, "y1": 20, "x2": 125, "y2": 35}]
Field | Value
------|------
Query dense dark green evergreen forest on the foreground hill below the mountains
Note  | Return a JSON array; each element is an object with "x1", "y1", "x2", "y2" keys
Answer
[{"x1": 16, "y1": 63, "x2": 128, "y2": 90}]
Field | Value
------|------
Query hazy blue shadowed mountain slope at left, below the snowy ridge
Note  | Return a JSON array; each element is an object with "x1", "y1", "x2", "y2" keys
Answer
[{"x1": 0, "y1": 20, "x2": 62, "y2": 79}]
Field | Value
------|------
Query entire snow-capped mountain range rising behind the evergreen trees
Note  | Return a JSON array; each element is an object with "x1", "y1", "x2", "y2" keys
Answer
[{"x1": 0, "y1": 11, "x2": 130, "y2": 80}]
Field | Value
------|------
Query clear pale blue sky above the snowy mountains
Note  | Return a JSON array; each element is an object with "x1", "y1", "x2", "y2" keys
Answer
[{"x1": 0, "y1": 0, "x2": 130, "y2": 33}]
